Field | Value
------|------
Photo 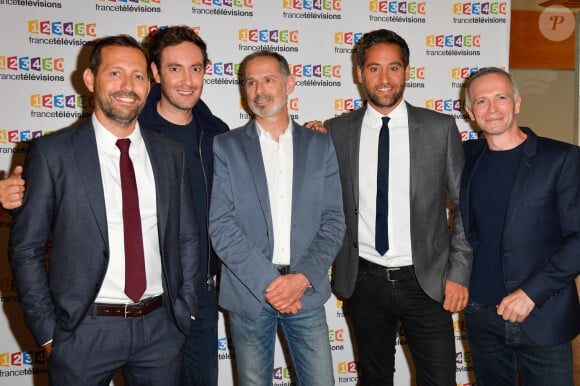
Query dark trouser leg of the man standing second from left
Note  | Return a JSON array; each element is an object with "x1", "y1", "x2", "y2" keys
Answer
[{"x1": 181, "y1": 287, "x2": 218, "y2": 386}]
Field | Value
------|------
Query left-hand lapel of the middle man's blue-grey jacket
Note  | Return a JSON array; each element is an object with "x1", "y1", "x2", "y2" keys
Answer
[{"x1": 242, "y1": 121, "x2": 274, "y2": 247}]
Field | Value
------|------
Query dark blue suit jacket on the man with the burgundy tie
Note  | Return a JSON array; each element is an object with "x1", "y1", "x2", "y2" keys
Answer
[{"x1": 10, "y1": 119, "x2": 199, "y2": 344}]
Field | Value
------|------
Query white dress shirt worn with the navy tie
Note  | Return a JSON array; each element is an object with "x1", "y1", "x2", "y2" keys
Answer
[{"x1": 358, "y1": 101, "x2": 413, "y2": 267}]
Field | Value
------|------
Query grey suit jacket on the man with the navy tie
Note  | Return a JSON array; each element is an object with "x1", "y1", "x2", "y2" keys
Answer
[{"x1": 326, "y1": 104, "x2": 472, "y2": 301}]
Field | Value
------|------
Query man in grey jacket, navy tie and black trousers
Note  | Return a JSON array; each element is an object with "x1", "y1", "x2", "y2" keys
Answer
[{"x1": 314, "y1": 30, "x2": 472, "y2": 386}]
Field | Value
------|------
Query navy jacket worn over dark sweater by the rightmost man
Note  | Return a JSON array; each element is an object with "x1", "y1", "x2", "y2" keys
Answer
[{"x1": 461, "y1": 128, "x2": 580, "y2": 345}]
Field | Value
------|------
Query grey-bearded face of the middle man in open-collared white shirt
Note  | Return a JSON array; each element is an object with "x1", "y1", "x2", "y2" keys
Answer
[{"x1": 244, "y1": 56, "x2": 295, "y2": 118}]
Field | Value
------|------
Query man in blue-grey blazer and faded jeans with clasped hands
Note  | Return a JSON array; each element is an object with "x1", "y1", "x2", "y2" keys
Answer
[{"x1": 209, "y1": 51, "x2": 345, "y2": 386}]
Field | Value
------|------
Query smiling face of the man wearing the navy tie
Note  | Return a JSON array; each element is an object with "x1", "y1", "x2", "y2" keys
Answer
[{"x1": 357, "y1": 43, "x2": 410, "y2": 115}]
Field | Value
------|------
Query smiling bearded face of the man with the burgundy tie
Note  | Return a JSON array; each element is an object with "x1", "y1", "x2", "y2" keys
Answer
[{"x1": 83, "y1": 46, "x2": 149, "y2": 137}]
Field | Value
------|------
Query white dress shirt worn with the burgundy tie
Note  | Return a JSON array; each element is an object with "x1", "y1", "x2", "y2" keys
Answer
[{"x1": 92, "y1": 114, "x2": 163, "y2": 304}]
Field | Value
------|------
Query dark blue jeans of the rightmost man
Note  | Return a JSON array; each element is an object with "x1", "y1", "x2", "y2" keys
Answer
[{"x1": 465, "y1": 301, "x2": 574, "y2": 386}]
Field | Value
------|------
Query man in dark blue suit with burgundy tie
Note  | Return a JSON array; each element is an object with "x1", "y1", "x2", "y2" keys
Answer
[{"x1": 10, "y1": 35, "x2": 199, "y2": 386}]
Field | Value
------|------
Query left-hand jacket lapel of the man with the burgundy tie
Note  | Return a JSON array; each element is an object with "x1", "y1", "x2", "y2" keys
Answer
[{"x1": 71, "y1": 119, "x2": 109, "y2": 248}]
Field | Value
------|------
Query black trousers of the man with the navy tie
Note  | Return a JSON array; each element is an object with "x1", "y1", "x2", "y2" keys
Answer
[{"x1": 347, "y1": 259, "x2": 456, "y2": 386}]
